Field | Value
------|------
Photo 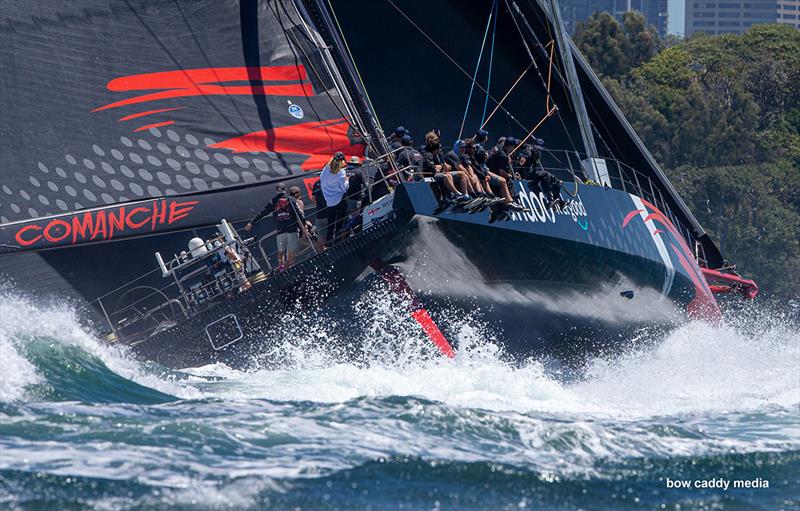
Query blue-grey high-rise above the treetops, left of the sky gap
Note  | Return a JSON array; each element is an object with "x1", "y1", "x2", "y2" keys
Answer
[{"x1": 559, "y1": 0, "x2": 672, "y2": 36}]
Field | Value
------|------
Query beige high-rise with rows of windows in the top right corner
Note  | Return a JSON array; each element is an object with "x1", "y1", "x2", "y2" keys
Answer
[{"x1": 685, "y1": 0, "x2": 800, "y2": 37}]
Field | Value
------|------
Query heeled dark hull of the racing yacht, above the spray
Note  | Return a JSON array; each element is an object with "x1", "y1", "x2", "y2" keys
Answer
[{"x1": 108, "y1": 183, "x2": 716, "y2": 367}]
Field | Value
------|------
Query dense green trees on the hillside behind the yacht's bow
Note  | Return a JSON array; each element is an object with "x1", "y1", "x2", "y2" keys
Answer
[{"x1": 574, "y1": 11, "x2": 800, "y2": 298}]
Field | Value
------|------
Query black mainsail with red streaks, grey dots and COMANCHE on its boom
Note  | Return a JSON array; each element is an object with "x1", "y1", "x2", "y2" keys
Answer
[{"x1": 0, "y1": 0, "x2": 368, "y2": 252}]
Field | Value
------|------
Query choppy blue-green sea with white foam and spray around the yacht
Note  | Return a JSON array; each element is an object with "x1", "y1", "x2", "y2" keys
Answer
[{"x1": 0, "y1": 287, "x2": 800, "y2": 509}]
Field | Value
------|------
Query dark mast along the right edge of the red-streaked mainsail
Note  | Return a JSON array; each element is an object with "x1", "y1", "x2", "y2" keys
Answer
[{"x1": 296, "y1": 0, "x2": 389, "y2": 156}]
